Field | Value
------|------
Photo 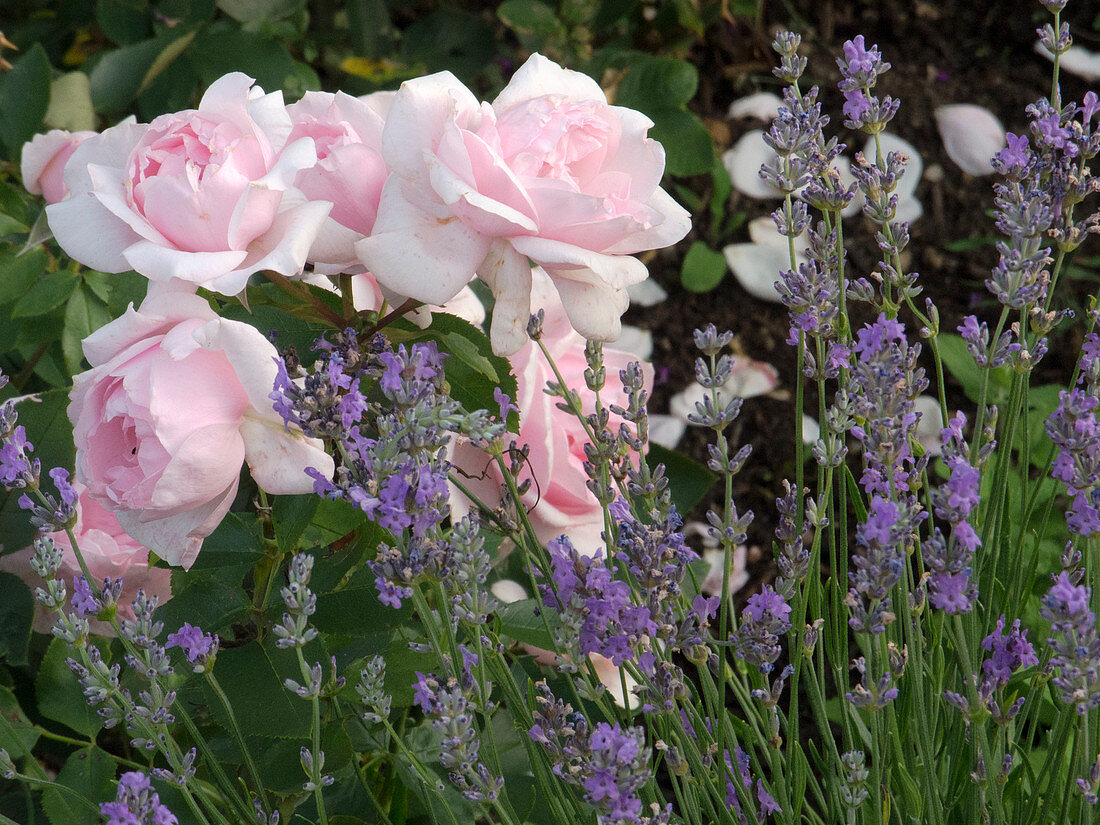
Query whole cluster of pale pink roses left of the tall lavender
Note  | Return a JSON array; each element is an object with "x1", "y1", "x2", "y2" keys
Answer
[{"x1": 4, "y1": 55, "x2": 690, "y2": 620}]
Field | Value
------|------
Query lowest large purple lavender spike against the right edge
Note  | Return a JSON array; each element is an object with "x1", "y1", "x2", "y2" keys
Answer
[{"x1": 1040, "y1": 571, "x2": 1100, "y2": 716}]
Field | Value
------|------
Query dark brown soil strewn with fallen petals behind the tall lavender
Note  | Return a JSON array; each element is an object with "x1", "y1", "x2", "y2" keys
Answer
[{"x1": 626, "y1": 0, "x2": 1100, "y2": 578}]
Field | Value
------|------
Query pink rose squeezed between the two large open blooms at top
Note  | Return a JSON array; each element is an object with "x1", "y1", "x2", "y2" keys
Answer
[{"x1": 286, "y1": 91, "x2": 389, "y2": 274}]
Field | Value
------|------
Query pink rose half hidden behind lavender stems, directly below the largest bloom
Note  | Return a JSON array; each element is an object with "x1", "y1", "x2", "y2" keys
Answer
[{"x1": 451, "y1": 270, "x2": 653, "y2": 556}]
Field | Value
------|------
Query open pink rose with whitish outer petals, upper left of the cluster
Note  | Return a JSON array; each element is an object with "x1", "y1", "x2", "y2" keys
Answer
[{"x1": 46, "y1": 73, "x2": 330, "y2": 295}]
